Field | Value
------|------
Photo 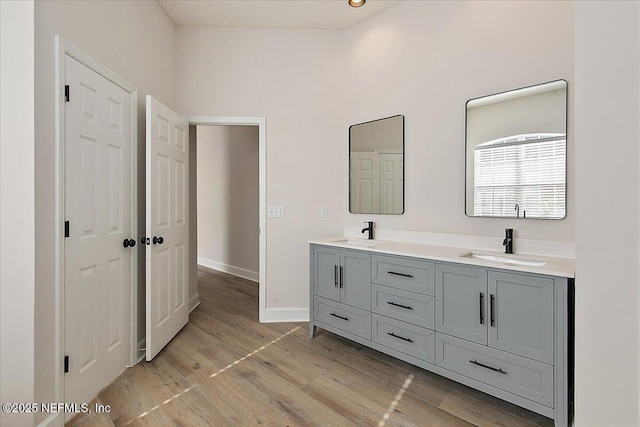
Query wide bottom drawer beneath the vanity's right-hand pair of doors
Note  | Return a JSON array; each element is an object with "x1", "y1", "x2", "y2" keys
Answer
[{"x1": 436, "y1": 333, "x2": 553, "y2": 408}]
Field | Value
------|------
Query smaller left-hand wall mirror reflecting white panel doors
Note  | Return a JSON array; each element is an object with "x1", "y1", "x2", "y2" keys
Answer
[{"x1": 349, "y1": 115, "x2": 404, "y2": 215}]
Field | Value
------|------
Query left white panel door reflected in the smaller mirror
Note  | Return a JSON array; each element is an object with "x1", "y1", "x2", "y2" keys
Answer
[{"x1": 349, "y1": 151, "x2": 379, "y2": 213}]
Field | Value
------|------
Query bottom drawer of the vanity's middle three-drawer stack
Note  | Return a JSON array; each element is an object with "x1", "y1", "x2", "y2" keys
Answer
[{"x1": 371, "y1": 314, "x2": 435, "y2": 363}]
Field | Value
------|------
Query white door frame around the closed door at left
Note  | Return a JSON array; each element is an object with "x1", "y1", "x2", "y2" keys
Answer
[{"x1": 52, "y1": 34, "x2": 138, "y2": 418}]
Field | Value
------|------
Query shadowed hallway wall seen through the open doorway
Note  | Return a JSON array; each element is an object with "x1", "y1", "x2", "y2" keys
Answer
[{"x1": 197, "y1": 126, "x2": 260, "y2": 281}]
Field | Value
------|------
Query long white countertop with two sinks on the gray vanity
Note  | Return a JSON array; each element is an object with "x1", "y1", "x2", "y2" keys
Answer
[{"x1": 309, "y1": 236, "x2": 575, "y2": 278}]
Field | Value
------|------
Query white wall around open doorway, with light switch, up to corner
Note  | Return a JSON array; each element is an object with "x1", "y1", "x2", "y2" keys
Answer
[{"x1": 176, "y1": 27, "x2": 348, "y2": 319}]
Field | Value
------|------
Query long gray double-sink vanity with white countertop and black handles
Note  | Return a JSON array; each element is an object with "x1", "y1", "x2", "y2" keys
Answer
[{"x1": 310, "y1": 237, "x2": 573, "y2": 426}]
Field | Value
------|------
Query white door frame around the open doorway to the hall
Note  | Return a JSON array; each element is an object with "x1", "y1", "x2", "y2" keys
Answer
[{"x1": 187, "y1": 116, "x2": 267, "y2": 323}]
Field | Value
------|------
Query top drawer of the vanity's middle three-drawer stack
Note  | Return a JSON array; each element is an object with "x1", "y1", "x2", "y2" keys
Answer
[{"x1": 371, "y1": 255, "x2": 435, "y2": 295}]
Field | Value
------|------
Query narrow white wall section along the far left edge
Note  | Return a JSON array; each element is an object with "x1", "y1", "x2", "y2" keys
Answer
[{"x1": 0, "y1": 1, "x2": 35, "y2": 426}]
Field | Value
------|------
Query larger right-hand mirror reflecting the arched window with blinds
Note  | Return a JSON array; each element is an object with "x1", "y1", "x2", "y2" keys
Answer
[{"x1": 465, "y1": 80, "x2": 567, "y2": 219}]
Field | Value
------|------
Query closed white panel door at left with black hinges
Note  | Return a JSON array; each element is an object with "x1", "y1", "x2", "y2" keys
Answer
[{"x1": 64, "y1": 56, "x2": 135, "y2": 415}]
